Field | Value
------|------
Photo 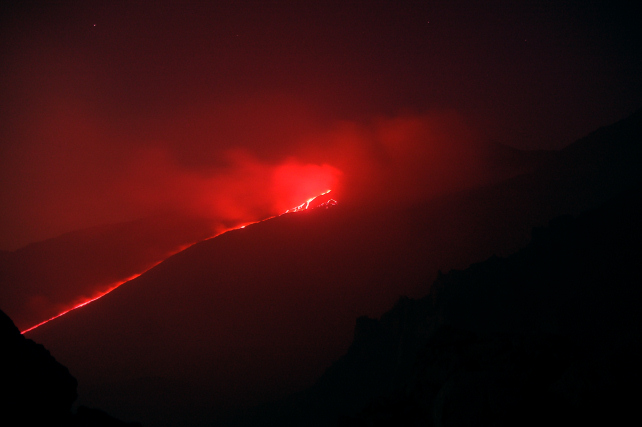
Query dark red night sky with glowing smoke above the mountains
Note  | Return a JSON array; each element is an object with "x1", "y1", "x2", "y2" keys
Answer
[{"x1": 0, "y1": 0, "x2": 642, "y2": 249}]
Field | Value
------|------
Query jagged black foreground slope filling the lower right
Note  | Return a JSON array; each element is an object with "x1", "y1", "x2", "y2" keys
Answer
[{"x1": 238, "y1": 183, "x2": 642, "y2": 426}]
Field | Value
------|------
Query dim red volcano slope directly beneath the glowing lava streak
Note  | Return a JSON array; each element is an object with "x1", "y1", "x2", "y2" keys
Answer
[{"x1": 28, "y1": 108, "x2": 641, "y2": 425}]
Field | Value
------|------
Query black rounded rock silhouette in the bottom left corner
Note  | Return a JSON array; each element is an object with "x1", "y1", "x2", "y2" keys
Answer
[{"x1": 0, "y1": 311, "x2": 77, "y2": 425}]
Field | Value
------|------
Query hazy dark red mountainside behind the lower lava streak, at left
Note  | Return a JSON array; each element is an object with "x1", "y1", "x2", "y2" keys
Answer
[{"x1": 0, "y1": 215, "x2": 214, "y2": 330}]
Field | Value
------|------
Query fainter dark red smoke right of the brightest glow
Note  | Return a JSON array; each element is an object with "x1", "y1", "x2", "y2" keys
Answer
[{"x1": 308, "y1": 110, "x2": 490, "y2": 205}]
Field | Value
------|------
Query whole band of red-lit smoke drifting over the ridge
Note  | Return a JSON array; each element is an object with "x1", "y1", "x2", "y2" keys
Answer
[{"x1": 1, "y1": 93, "x2": 500, "y2": 249}]
